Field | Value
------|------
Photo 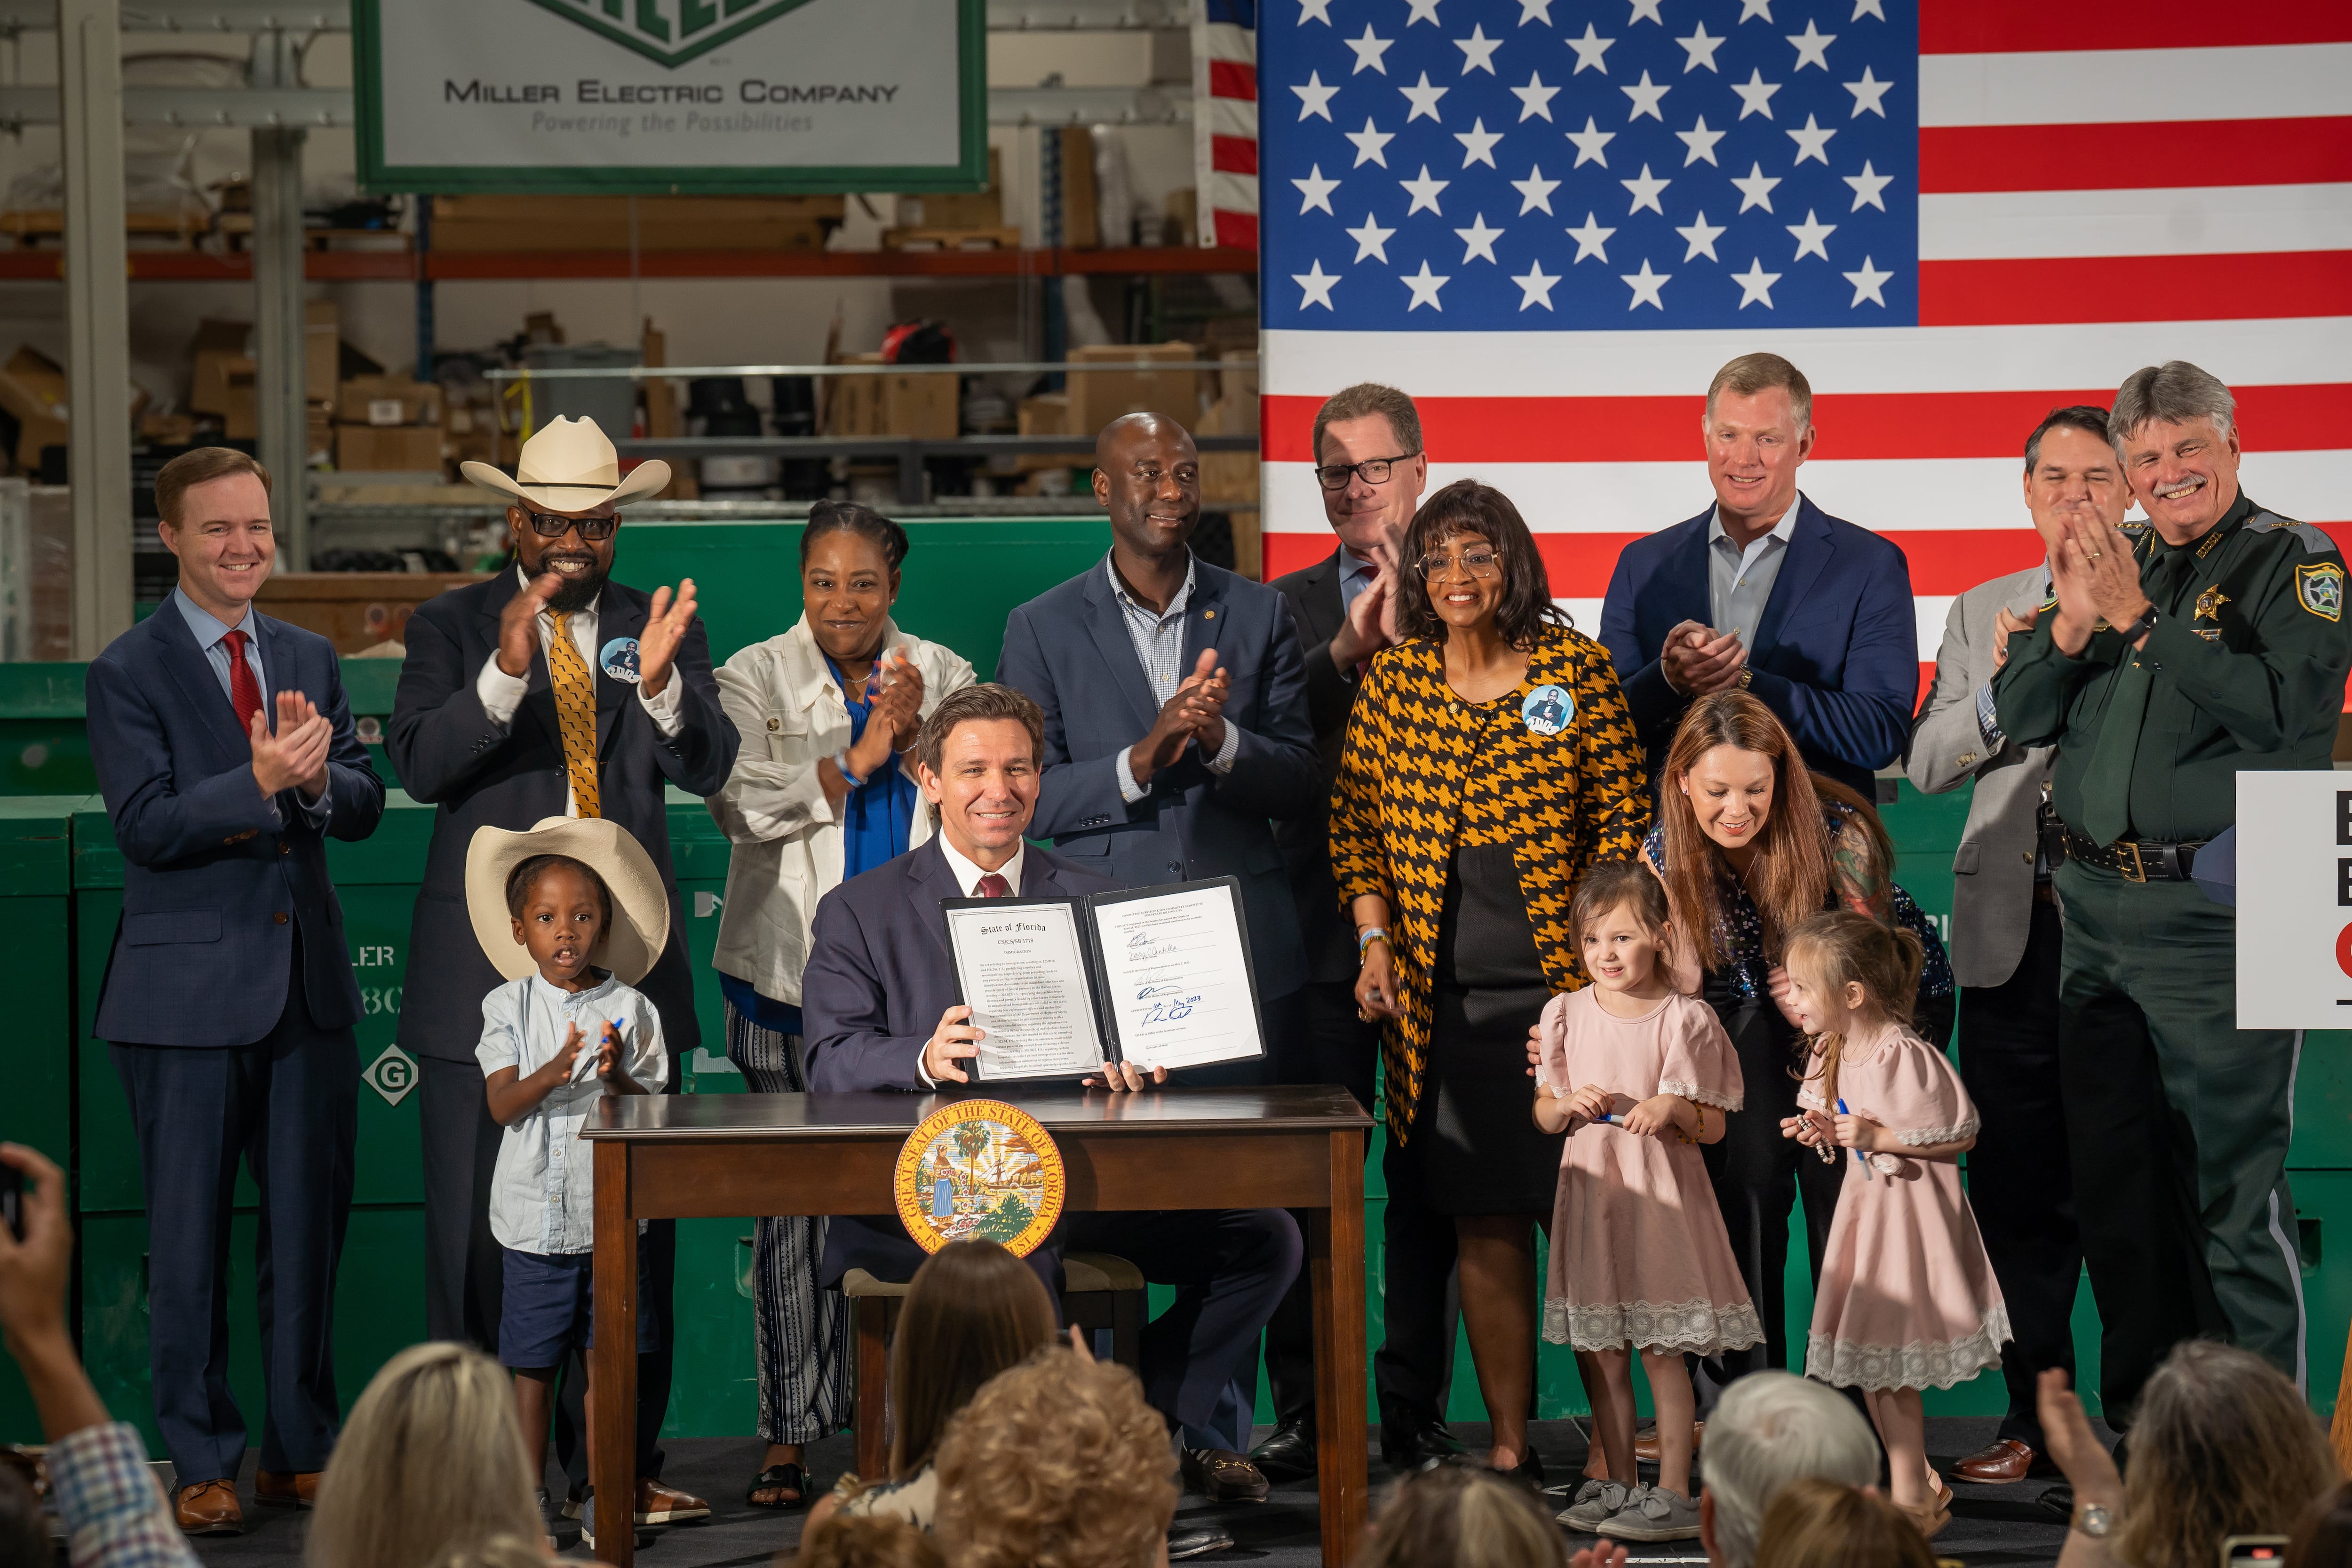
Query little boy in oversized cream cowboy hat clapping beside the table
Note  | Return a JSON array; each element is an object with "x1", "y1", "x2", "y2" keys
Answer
[{"x1": 466, "y1": 816, "x2": 670, "y2": 1547}]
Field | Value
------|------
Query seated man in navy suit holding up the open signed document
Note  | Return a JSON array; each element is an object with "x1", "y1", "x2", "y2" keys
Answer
[{"x1": 800, "y1": 686, "x2": 1301, "y2": 1500}]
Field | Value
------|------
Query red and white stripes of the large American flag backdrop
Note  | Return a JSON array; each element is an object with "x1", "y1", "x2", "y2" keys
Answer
[{"x1": 1263, "y1": 0, "x2": 2352, "y2": 700}]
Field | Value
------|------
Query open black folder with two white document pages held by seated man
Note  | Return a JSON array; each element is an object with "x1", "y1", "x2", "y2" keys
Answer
[{"x1": 938, "y1": 877, "x2": 1265, "y2": 1079}]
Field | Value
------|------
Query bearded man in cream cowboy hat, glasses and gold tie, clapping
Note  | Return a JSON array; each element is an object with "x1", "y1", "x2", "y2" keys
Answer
[{"x1": 388, "y1": 418, "x2": 736, "y2": 1523}]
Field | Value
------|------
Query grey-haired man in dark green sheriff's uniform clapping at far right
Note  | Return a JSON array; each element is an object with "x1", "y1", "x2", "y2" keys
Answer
[{"x1": 1994, "y1": 360, "x2": 2352, "y2": 1420}]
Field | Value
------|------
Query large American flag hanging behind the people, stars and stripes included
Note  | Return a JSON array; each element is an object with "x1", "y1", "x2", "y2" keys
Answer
[{"x1": 1258, "y1": 0, "x2": 2352, "y2": 691}]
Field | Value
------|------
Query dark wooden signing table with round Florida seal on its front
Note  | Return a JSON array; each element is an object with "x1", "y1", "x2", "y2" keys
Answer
[{"x1": 581, "y1": 1086, "x2": 1371, "y2": 1566}]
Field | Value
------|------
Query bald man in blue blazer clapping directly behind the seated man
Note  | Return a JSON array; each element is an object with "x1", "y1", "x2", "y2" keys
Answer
[{"x1": 997, "y1": 414, "x2": 1327, "y2": 1084}]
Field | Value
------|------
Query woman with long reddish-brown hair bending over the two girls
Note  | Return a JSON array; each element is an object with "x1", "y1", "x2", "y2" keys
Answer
[{"x1": 1642, "y1": 691, "x2": 1952, "y2": 1387}]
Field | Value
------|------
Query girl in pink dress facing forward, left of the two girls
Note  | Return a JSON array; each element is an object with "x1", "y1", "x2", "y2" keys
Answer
[{"x1": 1536, "y1": 860, "x2": 1764, "y2": 1540}]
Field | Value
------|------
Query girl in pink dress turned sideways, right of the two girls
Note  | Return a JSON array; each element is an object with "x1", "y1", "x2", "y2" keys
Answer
[{"x1": 1780, "y1": 910, "x2": 2011, "y2": 1535}]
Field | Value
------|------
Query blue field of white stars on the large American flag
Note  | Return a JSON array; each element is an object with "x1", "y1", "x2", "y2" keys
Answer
[{"x1": 1258, "y1": 0, "x2": 1919, "y2": 332}]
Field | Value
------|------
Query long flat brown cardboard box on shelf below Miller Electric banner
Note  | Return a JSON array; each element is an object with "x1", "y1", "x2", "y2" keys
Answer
[{"x1": 433, "y1": 195, "x2": 847, "y2": 252}]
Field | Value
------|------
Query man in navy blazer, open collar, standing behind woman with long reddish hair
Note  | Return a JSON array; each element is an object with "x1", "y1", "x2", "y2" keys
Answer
[{"x1": 1602, "y1": 355, "x2": 1919, "y2": 799}]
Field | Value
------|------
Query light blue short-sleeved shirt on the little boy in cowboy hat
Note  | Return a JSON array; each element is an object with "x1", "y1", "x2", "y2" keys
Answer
[{"x1": 473, "y1": 973, "x2": 670, "y2": 1258}]
